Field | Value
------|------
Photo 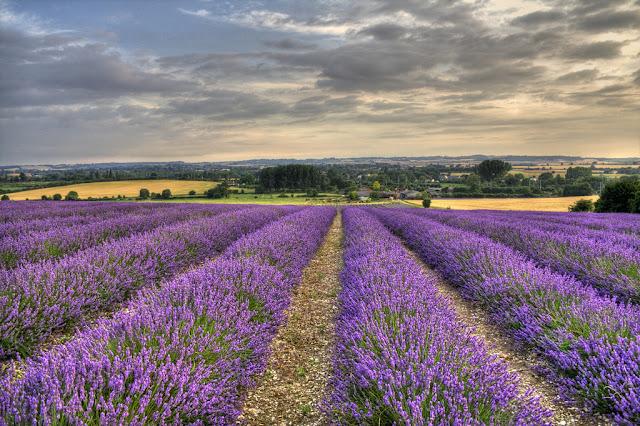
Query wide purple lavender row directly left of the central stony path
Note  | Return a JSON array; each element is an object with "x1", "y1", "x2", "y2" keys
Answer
[{"x1": 0, "y1": 207, "x2": 335, "y2": 425}]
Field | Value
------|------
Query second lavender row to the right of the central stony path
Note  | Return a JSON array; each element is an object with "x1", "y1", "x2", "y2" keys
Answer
[{"x1": 372, "y1": 209, "x2": 640, "y2": 425}]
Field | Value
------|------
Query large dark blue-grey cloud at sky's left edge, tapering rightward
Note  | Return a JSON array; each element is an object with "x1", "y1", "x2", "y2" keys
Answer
[{"x1": 0, "y1": 31, "x2": 196, "y2": 107}]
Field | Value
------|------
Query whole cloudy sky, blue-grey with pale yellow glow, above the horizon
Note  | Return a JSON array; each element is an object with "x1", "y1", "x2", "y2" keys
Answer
[{"x1": 0, "y1": 0, "x2": 640, "y2": 164}]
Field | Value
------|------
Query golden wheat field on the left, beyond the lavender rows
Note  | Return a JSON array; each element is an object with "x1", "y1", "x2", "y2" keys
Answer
[{"x1": 8, "y1": 179, "x2": 218, "y2": 200}]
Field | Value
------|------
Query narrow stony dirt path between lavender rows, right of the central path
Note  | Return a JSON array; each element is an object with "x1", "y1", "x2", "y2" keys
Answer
[{"x1": 407, "y1": 249, "x2": 612, "y2": 426}]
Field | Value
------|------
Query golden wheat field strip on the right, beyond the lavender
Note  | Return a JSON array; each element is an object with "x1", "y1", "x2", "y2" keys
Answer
[{"x1": 410, "y1": 195, "x2": 600, "y2": 212}]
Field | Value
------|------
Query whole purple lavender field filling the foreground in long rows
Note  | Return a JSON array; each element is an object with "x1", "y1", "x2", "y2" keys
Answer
[{"x1": 0, "y1": 202, "x2": 640, "y2": 425}]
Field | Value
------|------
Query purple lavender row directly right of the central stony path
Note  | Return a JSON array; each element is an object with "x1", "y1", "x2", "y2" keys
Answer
[{"x1": 328, "y1": 208, "x2": 550, "y2": 425}]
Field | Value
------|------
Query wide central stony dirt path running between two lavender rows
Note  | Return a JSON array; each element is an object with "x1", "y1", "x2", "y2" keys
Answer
[{"x1": 239, "y1": 213, "x2": 344, "y2": 425}]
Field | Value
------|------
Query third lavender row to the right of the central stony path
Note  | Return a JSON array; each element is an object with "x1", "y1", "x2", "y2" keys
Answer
[{"x1": 404, "y1": 209, "x2": 640, "y2": 303}]
